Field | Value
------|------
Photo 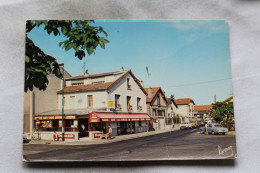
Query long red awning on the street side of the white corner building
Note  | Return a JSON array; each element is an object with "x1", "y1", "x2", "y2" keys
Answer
[{"x1": 89, "y1": 112, "x2": 151, "y2": 123}]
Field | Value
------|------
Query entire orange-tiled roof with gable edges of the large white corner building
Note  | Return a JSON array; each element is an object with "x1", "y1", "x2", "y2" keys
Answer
[{"x1": 57, "y1": 70, "x2": 147, "y2": 95}]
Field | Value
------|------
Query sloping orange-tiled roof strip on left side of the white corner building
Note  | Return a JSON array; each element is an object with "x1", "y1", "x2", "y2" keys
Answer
[{"x1": 58, "y1": 82, "x2": 114, "y2": 94}]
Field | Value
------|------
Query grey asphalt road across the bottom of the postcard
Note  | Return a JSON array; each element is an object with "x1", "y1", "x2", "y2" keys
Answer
[{"x1": 23, "y1": 129, "x2": 236, "y2": 162}]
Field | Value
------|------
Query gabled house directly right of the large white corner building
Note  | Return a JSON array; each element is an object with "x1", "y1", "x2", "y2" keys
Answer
[{"x1": 145, "y1": 87, "x2": 169, "y2": 130}]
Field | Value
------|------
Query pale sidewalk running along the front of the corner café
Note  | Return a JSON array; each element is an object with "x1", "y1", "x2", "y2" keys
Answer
[{"x1": 29, "y1": 125, "x2": 180, "y2": 145}]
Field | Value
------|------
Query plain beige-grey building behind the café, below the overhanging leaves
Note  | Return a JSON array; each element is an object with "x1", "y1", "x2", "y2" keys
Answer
[{"x1": 23, "y1": 67, "x2": 71, "y2": 139}]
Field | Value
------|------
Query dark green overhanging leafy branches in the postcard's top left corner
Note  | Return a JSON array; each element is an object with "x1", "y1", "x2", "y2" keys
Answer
[{"x1": 24, "y1": 20, "x2": 109, "y2": 92}]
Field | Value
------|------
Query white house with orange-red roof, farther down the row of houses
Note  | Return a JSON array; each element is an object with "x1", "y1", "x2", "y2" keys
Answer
[{"x1": 175, "y1": 98, "x2": 195, "y2": 122}]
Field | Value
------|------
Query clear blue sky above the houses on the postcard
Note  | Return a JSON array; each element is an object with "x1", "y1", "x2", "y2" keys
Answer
[{"x1": 28, "y1": 20, "x2": 232, "y2": 105}]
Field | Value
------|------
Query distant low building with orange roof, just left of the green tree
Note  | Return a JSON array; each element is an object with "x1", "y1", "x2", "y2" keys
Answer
[{"x1": 193, "y1": 105, "x2": 212, "y2": 121}]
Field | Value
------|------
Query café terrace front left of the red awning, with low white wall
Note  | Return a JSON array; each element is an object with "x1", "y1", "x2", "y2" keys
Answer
[{"x1": 33, "y1": 115, "x2": 79, "y2": 140}]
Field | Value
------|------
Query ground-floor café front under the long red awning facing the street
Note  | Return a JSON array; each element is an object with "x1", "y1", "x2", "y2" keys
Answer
[{"x1": 89, "y1": 112, "x2": 151, "y2": 139}]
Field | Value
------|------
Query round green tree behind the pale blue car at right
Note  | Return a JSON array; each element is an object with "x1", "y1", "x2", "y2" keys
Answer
[{"x1": 210, "y1": 102, "x2": 234, "y2": 122}]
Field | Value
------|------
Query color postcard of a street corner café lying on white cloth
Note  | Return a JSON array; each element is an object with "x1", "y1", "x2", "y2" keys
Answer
[{"x1": 23, "y1": 20, "x2": 237, "y2": 162}]
